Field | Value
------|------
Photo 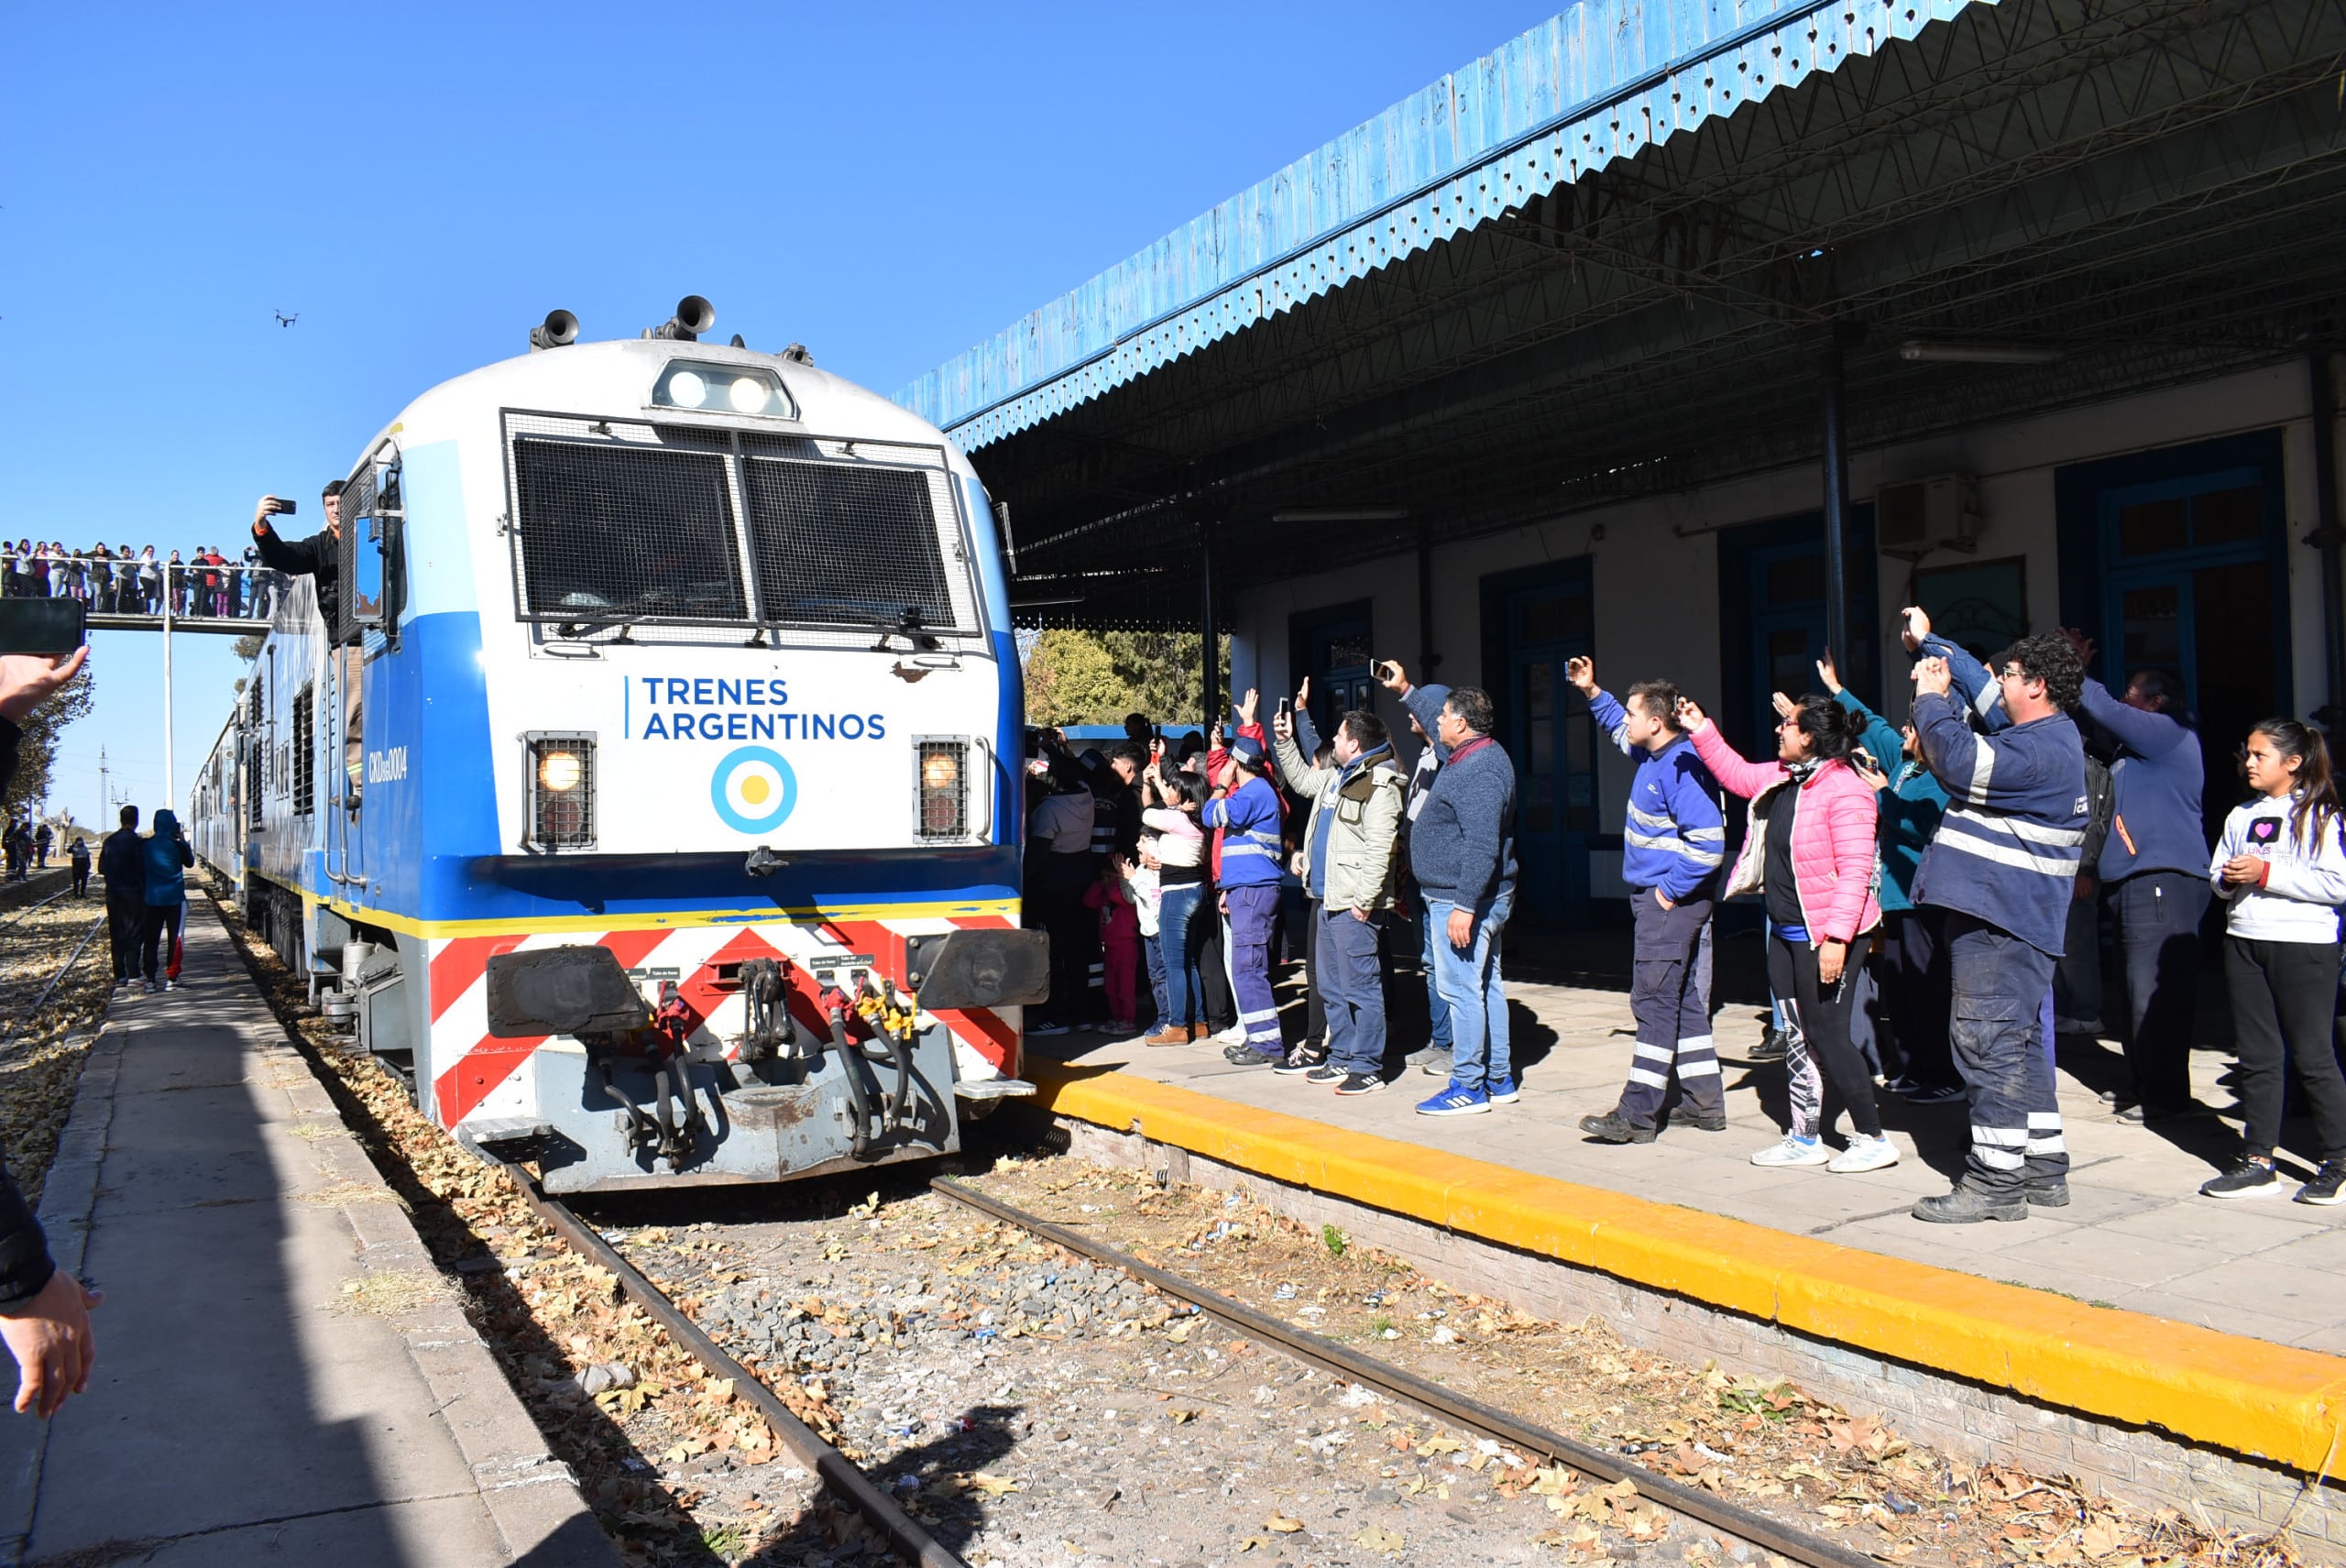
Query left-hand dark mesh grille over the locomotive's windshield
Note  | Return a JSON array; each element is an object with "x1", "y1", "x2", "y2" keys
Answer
[{"x1": 514, "y1": 436, "x2": 749, "y2": 622}]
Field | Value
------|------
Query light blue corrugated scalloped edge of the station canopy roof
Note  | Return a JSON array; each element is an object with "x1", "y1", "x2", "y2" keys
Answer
[{"x1": 896, "y1": 0, "x2": 1997, "y2": 448}]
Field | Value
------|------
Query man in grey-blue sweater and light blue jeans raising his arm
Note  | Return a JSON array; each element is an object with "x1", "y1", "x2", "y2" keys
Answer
[{"x1": 1377, "y1": 662, "x2": 1518, "y2": 1115}]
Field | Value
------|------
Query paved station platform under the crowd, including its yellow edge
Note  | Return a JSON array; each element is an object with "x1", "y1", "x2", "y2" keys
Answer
[{"x1": 1030, "y1": 981, "x2": 2346, "y2": 1469}]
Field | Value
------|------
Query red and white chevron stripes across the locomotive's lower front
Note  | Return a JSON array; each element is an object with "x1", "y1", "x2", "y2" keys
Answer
[{"x1": 427, "y1": 916, "x2": 1018, "y2": 1126}]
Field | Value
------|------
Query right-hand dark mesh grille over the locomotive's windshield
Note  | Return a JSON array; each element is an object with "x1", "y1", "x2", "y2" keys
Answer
[{"x1": 741, "y1": 457, "x2": 955, "y2": 629}]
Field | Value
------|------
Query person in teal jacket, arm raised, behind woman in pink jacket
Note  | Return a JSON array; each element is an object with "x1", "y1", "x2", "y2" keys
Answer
[{"x1": 1815, "y1": 648, "x2": 1964, "y2": 1105}]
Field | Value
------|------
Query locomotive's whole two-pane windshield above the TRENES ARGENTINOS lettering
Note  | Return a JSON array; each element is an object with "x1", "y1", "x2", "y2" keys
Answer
[{"x1": 507, "y1": 415, "x2": 976, "y2": 631}]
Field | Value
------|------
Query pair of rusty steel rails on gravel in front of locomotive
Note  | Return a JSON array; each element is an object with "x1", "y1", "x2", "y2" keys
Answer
[{"x1": 507, "y1": 1167, "x2": 1904, "y2": 1568}]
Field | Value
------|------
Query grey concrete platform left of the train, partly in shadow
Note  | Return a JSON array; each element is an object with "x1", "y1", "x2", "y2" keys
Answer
[{"x1": 0, "y1": 904, "x2": 619, "y2": 1568}]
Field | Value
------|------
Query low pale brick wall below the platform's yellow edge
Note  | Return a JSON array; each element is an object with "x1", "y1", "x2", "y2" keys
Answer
[{"x1": 1056, "y1": 1120, "x2": 2346, "y2": 1565}]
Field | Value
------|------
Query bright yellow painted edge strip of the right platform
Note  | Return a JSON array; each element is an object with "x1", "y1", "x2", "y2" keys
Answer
[{"x1": 1027, "y1": 1061, "x2": 2346, "y2": 1472}]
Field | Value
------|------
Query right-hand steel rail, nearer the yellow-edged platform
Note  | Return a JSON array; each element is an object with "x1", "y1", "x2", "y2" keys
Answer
[{"x1": 929, "y1": 1176, "x2": 1880, "y2": 1568}]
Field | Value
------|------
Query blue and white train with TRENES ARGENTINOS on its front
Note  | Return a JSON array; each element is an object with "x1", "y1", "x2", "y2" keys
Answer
[{"x1": 194, "y1": 298, "x2": 1048, "y2": 1192}]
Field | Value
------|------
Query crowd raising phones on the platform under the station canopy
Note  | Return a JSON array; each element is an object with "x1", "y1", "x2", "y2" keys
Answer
[{"x1": 1027, "y1": 610, "x2": 2346, "y2": 1223}]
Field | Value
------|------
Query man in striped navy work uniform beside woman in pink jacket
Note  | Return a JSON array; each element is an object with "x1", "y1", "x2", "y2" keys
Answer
[{"x1": 1914, "y1": 634, "x2": 2090, "y2": 1225}]
